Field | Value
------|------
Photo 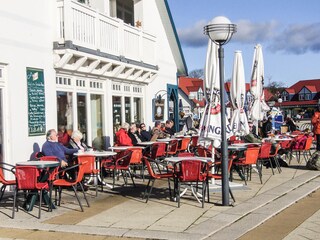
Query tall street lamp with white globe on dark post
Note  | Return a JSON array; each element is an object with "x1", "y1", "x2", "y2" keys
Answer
[{"x1": 204, "y1": 16, "x2": 237, "y2": 206}]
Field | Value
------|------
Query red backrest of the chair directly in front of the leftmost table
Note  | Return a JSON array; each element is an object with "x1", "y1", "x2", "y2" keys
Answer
[{"x1": 15, "y1": 166, "x2": 39, "y2": 190}]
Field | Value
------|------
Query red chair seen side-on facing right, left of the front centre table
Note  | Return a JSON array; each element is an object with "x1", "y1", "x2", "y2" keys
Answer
[{"x1": 143, "y1": 151, "x2": 174, "y2": 203}]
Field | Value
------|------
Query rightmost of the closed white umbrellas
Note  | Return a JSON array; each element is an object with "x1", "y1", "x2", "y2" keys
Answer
[{"x1": 250, "y1": 44, "x2": 270, "y2": 121}]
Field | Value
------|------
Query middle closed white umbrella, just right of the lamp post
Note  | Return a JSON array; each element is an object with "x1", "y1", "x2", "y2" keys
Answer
[{"x1": 230, "y1": 51, "x2": 249, "y2": 136}]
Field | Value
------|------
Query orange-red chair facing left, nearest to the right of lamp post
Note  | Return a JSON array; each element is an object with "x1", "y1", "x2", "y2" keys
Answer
[{"x1": 233, "y1": 147, "x2": 262, "y2": 185}]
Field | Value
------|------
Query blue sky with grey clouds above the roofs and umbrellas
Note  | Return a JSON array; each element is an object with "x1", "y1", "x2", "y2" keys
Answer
[{"x1": 167, "y1": 0, "x2": 320, "y2": 87}]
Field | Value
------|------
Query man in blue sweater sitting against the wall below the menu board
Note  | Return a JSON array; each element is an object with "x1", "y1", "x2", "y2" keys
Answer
[{"x1": 41, "y1": 129, "x2": 78, "y2": 167}]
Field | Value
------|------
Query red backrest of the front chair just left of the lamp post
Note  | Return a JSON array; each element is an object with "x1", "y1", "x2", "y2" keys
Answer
[{"x1": 179, "y1": 160, "x2": 205, "y2": 182}]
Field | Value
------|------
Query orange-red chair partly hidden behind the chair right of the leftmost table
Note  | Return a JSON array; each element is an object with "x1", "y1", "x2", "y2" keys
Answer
[{"x1": 78, "y1": 154, "x2": 100, "y2": 196}]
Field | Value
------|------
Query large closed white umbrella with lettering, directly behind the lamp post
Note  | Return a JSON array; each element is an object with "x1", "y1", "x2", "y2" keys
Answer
[{"x1": 199, "y1": 40, "x2": 232, "y2": 147}]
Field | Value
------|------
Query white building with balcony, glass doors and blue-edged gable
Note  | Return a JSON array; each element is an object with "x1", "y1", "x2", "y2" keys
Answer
[{"x1": 0, "y1": 0, "x2": 187, "y2": 164}]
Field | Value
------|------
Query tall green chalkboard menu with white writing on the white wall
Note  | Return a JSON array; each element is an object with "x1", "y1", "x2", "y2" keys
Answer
[{"x1": 27, "y1": 68, "x2": 46, "y2": 136}]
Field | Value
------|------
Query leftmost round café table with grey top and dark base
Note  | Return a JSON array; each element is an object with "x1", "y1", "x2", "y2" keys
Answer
[{"x1": 16, "y1": 161, "x2": 60, "y2": 212}]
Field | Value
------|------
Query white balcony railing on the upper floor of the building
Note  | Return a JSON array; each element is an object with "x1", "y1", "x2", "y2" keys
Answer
[{"x1": 57, "y1": 0, "x2": 157, "y2": 65}]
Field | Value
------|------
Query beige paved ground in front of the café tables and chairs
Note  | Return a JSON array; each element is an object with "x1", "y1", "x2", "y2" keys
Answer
[{"x1": 0, "y1": 154, "x2": 320, "y2": 239}]
